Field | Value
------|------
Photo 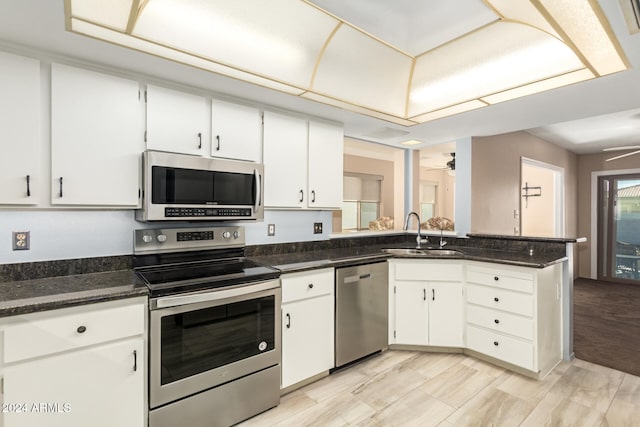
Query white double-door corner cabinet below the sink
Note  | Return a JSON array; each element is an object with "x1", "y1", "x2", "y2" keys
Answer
[{"x1": 389, "y1": 259, "x2": 464, "y2": 347}]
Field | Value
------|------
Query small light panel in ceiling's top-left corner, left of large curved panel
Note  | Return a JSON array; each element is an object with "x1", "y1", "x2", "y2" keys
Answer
[{"x1": 71, "y1": 0, "x2": 132, "y2": 31}]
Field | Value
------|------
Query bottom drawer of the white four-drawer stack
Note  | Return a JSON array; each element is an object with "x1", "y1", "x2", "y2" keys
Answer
[{"x1": 467, "y1": 325, "x2": 535, "y2": 371}]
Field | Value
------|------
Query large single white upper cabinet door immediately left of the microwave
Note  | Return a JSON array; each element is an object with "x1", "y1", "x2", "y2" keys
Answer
[{"x1": 51, "y1": 64, "x2": 144, "y2": 207}]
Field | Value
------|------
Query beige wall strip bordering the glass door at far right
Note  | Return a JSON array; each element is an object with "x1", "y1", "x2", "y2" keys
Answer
[{"x1": 576, "y1": 153, "x2": 640, "y2": 277}]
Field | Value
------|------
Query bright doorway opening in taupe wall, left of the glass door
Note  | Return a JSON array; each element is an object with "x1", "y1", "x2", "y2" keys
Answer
[{"x1": 516, "y1": 157, "x2": 564, "y2": 237}]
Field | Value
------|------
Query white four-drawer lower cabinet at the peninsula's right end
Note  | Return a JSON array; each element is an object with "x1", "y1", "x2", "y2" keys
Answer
[{"x1": 466, "y1": 263, "x2": 562, "y2": 377}]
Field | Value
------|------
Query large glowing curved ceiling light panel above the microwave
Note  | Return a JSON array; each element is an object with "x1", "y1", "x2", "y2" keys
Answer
[{"x1": 133, "y1": 0, "x2": 338, "y2": 88}]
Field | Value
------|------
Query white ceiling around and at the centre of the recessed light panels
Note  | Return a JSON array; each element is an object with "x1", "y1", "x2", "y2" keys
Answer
[{"x1": 0, "y1": 0, "x2": 640, "y2": 153}]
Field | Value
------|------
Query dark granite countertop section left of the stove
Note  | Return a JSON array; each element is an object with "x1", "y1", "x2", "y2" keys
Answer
[{"x1": 0, "y1": 270, "x2": 147, "y2": 317}]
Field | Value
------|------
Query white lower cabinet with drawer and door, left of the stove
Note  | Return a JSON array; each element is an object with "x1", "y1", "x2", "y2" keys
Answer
[{"x1": 0, "y1": 298, "x2": 147, "y2": 427}]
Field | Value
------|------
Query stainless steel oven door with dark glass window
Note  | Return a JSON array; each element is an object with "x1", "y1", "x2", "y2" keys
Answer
[{"x1": 149, "y1": 280, "x2": 281, "y2": 409}]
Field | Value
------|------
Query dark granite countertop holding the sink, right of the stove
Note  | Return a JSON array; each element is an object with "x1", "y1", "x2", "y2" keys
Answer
[{"x1": 251, "y1": 244, "x2": 566, "y2": 273}]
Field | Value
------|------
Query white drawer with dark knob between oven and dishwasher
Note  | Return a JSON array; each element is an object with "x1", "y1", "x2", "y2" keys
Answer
[{"x1": 281, "y1": 268, "x2": 334, "y2": 304}]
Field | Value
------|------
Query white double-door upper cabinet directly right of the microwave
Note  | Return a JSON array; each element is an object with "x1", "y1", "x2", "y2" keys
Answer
[{"x1": 263, "y1": 111, "x2": 343, "y2": 209}]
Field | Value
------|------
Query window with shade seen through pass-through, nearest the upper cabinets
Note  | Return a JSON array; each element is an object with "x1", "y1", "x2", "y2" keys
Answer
[{"x1": 342, "y1": 172, "x2": 383, "y2": 230}]
